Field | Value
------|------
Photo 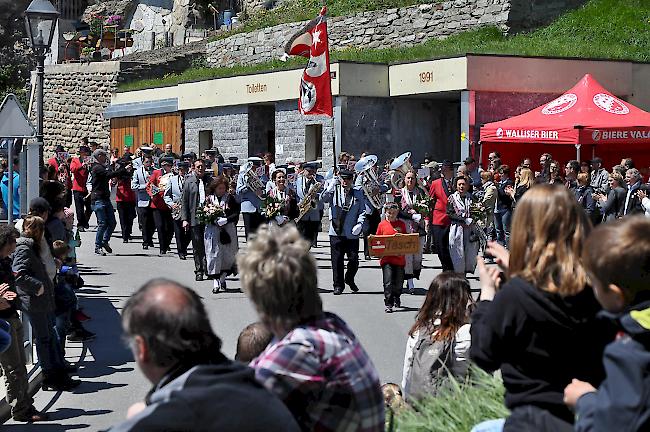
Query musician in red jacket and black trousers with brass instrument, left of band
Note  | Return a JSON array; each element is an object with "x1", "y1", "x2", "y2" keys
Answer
[{"x1": 148, "y1": 157, "x2": 174, "y2": 255}]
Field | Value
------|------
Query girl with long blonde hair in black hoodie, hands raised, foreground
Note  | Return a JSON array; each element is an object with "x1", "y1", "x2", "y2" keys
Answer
[{"x1": 470, "y1": 185, "x2": 615, "y2": 432}]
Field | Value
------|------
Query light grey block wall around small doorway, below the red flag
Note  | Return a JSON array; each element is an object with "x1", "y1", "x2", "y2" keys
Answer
[{"x1": 275, "y1": 101, "x2": 334, "y2": 167}]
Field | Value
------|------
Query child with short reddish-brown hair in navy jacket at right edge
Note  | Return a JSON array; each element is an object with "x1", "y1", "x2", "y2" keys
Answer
[{"x1": 564, "y1": 217, "x2": 650, "y2": 431}]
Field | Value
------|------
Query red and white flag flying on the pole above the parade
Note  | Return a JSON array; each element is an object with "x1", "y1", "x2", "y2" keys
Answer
[{"x1": 283, "y1": 6, "x2": 332, "y2": 117}]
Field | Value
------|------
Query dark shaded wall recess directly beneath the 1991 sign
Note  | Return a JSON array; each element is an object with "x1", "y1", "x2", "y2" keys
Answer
[{"x1": 341, "y1": 98, "x2": 460, "y2": 163}]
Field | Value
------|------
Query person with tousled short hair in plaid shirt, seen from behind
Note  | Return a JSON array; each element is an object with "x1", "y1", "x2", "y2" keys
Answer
[{"x1": 239, "y1": 226, "x2": 384, "y2": 432}]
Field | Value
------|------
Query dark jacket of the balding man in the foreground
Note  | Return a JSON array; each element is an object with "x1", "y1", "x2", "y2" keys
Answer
[{"x1": 111, "y1": 360, "x2": 300, "y2": 432}]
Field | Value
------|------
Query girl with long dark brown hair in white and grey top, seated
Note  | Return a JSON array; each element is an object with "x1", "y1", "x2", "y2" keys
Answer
[{"x1": 402, "y1": 272, "x2": 473, "y2": 402}]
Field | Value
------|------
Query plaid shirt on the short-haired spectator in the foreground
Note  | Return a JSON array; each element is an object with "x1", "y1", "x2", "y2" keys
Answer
[{"x1": 251, "y1": 312, "x2": 384, "y2": 432}]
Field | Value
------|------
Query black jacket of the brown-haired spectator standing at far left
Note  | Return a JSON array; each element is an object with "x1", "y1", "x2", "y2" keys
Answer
[{"x1": 12, "y1": 237, "x2": 54, "y2": 313}]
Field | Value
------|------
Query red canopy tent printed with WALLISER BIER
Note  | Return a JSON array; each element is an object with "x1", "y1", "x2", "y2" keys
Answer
[{"x1": 481, "y1": 74, "x2": 650, "y2": 173}]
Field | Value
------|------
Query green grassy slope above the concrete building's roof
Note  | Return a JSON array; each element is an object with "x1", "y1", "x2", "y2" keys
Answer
[{"x1": 120, "y1": 0, "x2": 650, "y2": 91}]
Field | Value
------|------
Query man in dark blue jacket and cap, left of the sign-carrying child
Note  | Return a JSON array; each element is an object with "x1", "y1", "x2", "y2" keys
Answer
[{"x1": 321, "y1": 170, "x2": 372, "y2": 295}]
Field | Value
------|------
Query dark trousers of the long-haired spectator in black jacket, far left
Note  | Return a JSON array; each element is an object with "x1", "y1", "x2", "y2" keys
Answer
[{"x1": 27, "y1": 312, "x2": 64, "y2": 376}]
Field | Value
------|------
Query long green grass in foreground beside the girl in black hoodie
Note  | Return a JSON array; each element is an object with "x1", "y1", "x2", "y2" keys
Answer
[{"x1": 395, "y1": 368, "x2": 508, "y2": 432}]
